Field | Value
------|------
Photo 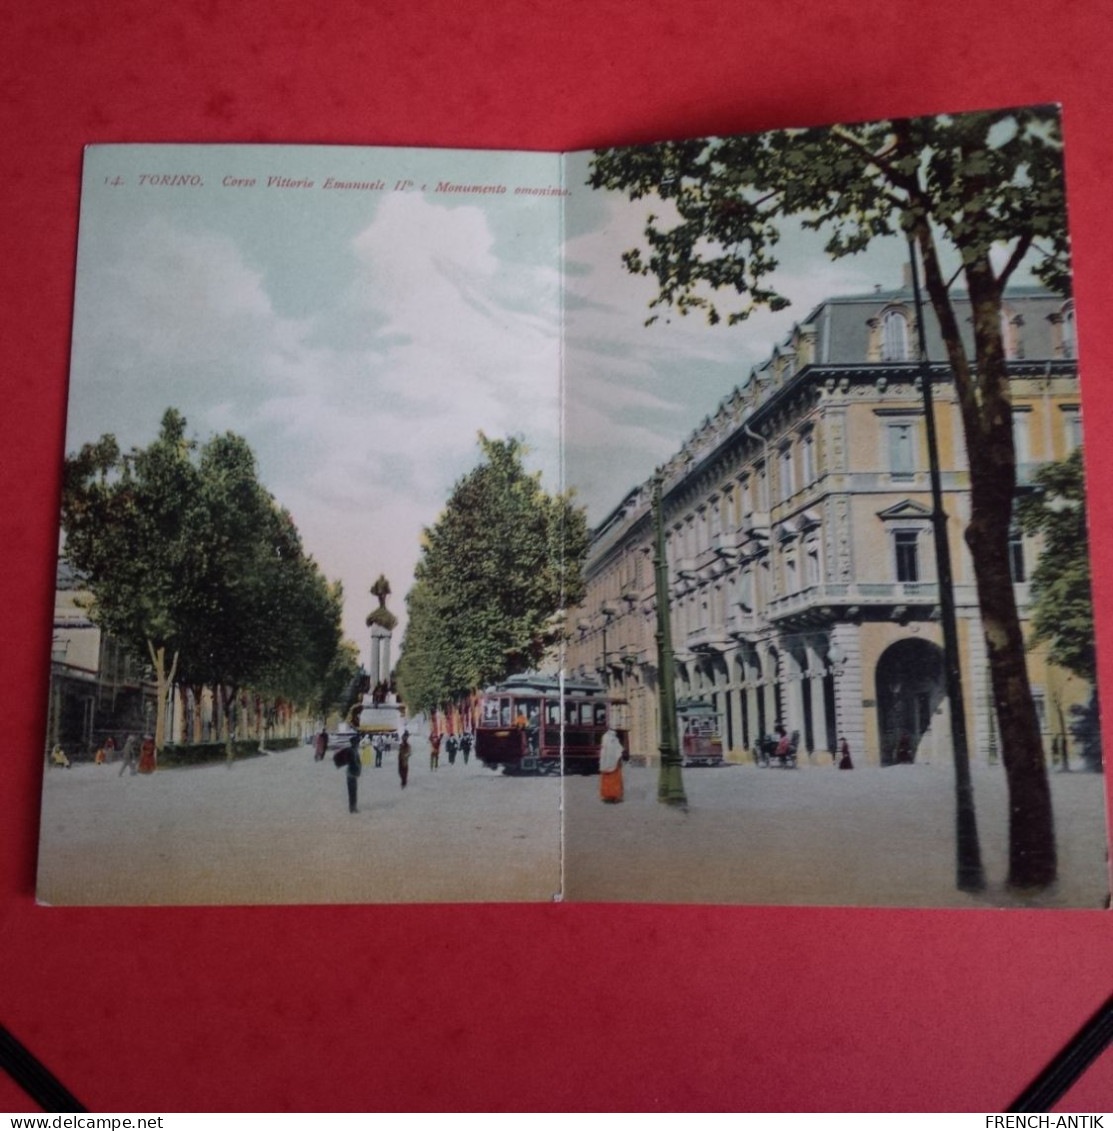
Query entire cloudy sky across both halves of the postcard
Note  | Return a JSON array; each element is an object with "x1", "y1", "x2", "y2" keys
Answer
[{"x1": 67, "y1": 136, "x2": 1045, "y2": 653}]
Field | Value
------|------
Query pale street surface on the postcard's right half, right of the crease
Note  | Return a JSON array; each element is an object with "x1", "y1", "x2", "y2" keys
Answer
[{"x1": 564, "y1": 762, "x2": 1108, "y2": 907}]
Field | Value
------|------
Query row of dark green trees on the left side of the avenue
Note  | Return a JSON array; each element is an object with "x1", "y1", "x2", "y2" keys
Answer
[{"x1": 62, "y1": 408, "x2": 357, "y2": 748}]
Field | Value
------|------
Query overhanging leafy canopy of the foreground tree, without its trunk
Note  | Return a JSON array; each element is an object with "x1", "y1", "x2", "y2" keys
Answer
[{"x1": 588, "y1": 107, "x2": 1070, "y2": 323}]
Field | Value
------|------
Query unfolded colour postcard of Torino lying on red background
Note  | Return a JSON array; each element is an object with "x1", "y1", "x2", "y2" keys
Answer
[{"x1": 38, "y1": 106, "x2": 1110, "y2": 907}]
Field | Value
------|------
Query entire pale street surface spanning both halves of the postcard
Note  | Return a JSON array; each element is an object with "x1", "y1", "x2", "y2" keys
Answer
[{"x1": 40, "y1": 739, "x2": 1108, "y2": 907}]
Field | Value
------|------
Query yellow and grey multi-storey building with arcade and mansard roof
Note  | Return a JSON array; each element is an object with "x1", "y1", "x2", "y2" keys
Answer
[{"x1": 567, "y1": 288, "x2": 1090, "y2": 765}]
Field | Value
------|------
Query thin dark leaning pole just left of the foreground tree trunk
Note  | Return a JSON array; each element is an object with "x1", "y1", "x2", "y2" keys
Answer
[{"x1": 908, "y1": 233, "x2": 985, "y2": 891}]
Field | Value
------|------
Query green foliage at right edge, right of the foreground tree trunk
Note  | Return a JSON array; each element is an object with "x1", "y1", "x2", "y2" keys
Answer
[{"x1": 1018, "y1": 448, "x2": 1096, "y2": 683}]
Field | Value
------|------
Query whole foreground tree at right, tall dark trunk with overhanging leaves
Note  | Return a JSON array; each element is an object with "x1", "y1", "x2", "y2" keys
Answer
[{"x1": 588, "y1": 107, "x2": 1069, "y2": 887}]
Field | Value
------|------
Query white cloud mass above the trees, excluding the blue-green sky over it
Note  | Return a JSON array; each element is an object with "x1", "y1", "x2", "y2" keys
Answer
[{"x1": 69, "y1": 195, "x2": 559, "y2": 646}]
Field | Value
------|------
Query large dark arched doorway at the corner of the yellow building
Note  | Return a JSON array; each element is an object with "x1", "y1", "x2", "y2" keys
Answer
[{"x1": 877, "y1": 639, "x2": 946, "y2": 766}]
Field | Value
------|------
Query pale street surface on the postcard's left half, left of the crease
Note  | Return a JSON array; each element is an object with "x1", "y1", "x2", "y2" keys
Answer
[{"x1": 38, "y1": 740, "x2": 560, "y2": 905}]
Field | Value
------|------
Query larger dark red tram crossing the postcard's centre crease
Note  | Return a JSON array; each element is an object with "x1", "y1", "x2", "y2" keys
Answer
[{"x1": 475, "y1": 675, "x2": 629, "y2": 774}]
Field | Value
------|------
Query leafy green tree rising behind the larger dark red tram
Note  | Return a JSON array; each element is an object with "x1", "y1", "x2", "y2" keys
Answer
[{"x1": 398, "y1": 433, "x2": 587, "y2": 710}]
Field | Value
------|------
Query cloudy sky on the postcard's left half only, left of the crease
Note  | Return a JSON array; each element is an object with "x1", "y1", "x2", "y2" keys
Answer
[{"x1": 67, "y1": 146, "x2": 561, "y2": 653}]
